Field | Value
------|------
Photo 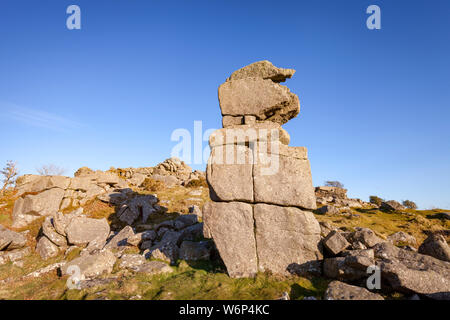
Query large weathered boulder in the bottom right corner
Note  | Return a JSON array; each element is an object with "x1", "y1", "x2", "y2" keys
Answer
[{"x1": 373, "y1": 242, "x2": 450, "y2": 300}]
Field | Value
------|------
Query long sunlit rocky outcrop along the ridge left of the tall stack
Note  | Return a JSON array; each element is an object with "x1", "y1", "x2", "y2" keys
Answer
[{"x1": 13, "y1": 158, "x2": 205, "y2": 228}]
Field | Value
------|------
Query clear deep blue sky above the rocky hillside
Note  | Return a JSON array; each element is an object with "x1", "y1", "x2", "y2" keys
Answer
[{"x1": 0, "y1": 0, "x2": 450, "y2": 208}]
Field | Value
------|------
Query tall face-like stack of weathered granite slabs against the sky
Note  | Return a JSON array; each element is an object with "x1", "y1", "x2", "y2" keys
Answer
[{"x1": 203, "y1": 61, "x2": 322, "y2": 277}]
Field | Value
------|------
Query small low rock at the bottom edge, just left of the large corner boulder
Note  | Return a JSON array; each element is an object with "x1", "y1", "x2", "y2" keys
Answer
[{"x1": 324, "y1": 281, "x2": 384, "y2": 300}]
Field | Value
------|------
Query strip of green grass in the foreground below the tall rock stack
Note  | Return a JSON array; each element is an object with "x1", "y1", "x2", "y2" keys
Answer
[{"x1": 61, "y1": 262, "x2": 328, "y2": 300}]
